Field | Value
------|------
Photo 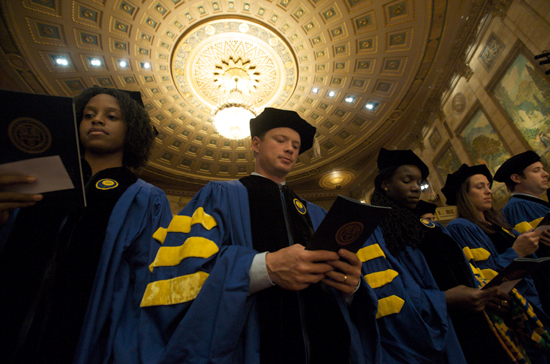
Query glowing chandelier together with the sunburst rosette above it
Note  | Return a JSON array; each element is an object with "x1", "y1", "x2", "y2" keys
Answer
[{"x1": 214, "y1": 57, "x2": 259, "y2": 139}]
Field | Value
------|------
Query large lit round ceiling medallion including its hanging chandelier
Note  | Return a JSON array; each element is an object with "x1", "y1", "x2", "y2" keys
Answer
[{"x1": 172, "y1": 18, "x2": 298, "y2": 139}]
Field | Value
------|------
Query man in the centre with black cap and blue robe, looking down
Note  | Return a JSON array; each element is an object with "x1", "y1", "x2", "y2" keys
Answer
[{"x1": 140, "y1": 108, "x2": 380, "y2": 364}]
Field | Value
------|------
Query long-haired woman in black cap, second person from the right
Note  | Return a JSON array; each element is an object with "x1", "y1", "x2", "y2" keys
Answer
[{"x1": 441, "y1": 164, "x2": 550, "y2": 363}]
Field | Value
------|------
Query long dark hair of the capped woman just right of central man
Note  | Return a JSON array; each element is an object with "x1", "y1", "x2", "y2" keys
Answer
[{"x1": 371, "y1": 166, "x2": 424, "y2": 256}]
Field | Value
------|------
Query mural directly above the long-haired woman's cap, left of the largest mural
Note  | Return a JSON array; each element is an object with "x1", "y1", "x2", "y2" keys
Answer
[{"x1": 460, "y1": 110, "x2": 510, "y2": 174}]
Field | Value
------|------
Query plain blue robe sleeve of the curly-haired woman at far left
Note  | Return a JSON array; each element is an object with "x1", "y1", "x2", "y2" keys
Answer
[{"x1": 74, "y1": 179, "x2": 172, "y2": 364}]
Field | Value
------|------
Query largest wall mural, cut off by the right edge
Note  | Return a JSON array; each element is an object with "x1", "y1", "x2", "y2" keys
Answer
[{"x1": 493, "y1": 54, "x2": 550, "y2": 165}]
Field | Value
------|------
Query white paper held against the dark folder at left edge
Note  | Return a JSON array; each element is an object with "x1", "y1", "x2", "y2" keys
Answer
[{"x1": 0, "y1": 155, "x2": 74, "y2": 194}]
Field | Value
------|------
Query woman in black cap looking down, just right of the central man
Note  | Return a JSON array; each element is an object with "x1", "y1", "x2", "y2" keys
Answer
[{"x1": 358, "y1": 148, "x2": 512, "y2": 364}]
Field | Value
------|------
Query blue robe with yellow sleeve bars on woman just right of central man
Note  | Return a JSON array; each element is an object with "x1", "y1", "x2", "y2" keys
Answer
[{"x1": 357, "y1": 227, "x2": 466, "y2": 364}]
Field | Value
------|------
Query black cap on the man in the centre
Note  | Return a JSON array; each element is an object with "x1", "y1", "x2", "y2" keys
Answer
[{"x1": 250, "y1": 107, "x2": 317, "y2": 154}]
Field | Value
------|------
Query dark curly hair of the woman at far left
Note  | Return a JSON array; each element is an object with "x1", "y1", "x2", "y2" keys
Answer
[{"x1": 75, "y1": 86, "x2": 155, "y2": 169}]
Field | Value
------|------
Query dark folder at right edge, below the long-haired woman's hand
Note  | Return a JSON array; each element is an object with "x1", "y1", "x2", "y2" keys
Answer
[{"x1": 482, "y1": 257, "x2": 550, "y2": 293}]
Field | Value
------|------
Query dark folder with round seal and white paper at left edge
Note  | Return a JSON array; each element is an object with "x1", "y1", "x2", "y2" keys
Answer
[{"x1": 0, "y1": 90, "x2": 86, "y2": 207}]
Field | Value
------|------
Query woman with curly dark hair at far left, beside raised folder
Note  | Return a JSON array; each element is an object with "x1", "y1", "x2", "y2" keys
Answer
[{"x1": 0, "y1": 87, "x2": 172, "y2": 363}]
